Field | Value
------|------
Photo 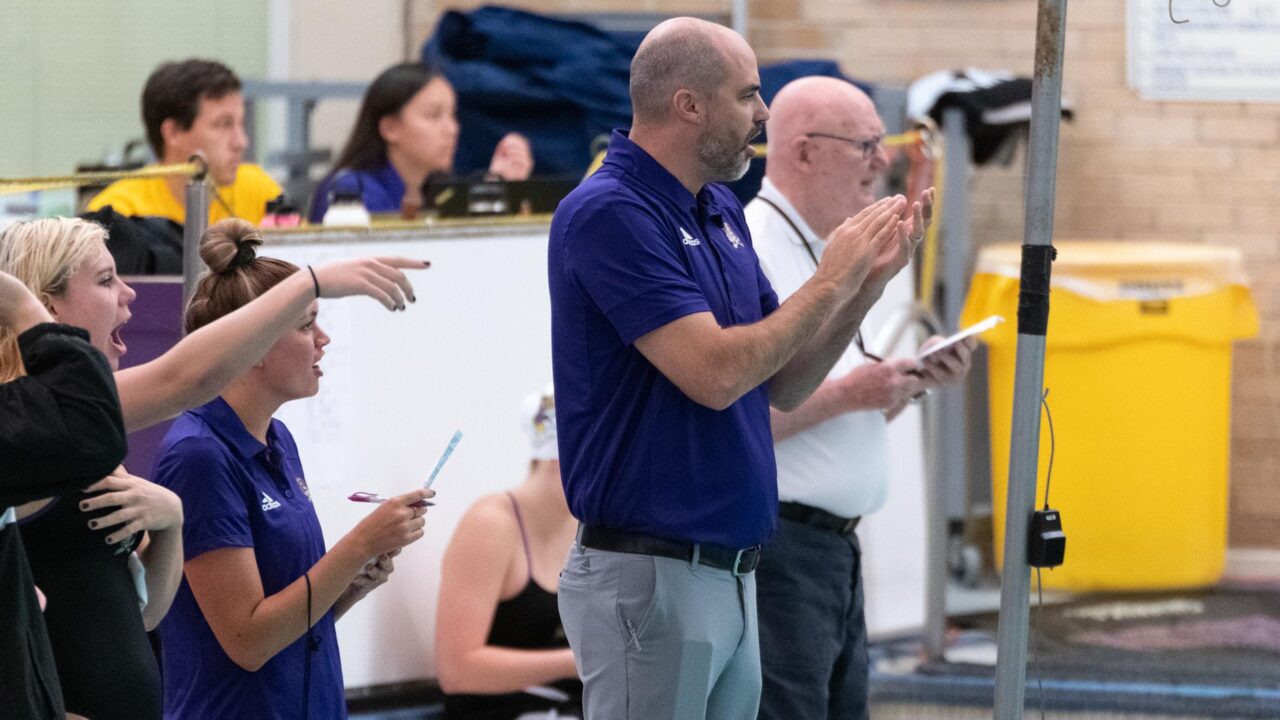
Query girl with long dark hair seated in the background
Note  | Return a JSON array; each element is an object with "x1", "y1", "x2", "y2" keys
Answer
[{"x1": 310, "y1": 63, "x2": 534, "y2": 223}]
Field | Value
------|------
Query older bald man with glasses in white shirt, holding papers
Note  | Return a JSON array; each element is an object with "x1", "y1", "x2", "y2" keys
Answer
[{"x1": 746, "y1": 77, "x2": 972, "y2": 720}]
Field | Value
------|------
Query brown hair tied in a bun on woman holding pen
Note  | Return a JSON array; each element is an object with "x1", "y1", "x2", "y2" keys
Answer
[{"x1": 184, "y1": 218, "x2": 298, "y2": 333}]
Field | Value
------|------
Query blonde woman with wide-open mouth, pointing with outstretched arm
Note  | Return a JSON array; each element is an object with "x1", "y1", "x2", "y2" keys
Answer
[{"x1": 0, "y1": 218, "x2": 426, "y2": 720}]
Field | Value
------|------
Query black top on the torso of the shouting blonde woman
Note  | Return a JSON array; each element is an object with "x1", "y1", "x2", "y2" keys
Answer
[{"x1": 18, "y1": 493, "x2": 163, "y2": 720}]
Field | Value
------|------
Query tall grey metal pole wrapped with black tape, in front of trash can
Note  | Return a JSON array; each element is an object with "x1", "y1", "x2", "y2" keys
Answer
[{"x1": 995, "y1": 0, "x2": 1066, "y2": 720}]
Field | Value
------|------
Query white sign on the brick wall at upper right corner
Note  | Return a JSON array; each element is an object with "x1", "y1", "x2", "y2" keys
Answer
[{"x1": 1126, "y1": 0, "x2": 1280, "y2": 101}]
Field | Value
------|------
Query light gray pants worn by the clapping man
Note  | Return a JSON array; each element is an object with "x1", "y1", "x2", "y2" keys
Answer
[{"x1": 559, "y1": 543, "x2": 760, "y2": 720}]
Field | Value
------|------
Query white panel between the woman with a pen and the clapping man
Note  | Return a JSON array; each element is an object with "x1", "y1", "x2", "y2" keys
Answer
[{"x1": 262, "y1": 227, "x2": 552, "y2": 687}]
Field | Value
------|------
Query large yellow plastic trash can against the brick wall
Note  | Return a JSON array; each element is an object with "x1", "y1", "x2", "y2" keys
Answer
[{"x1": 963, "y1": 242, "x2": 1258, "y2": 591}]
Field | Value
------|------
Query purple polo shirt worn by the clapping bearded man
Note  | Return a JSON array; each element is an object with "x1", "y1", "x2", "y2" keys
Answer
[{"x1": 548, "y1": 131, "x2": 778, "y2": 548}]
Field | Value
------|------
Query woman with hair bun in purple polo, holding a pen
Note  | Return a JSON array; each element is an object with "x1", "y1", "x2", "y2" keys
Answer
[{"x1": 155, "y1": 220, "x2": 434, "y2": 719}]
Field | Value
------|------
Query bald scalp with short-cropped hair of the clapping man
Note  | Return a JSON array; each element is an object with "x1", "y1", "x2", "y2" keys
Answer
[{"x1": 631, "y1": 18, "x2": 754, "y2": 124}]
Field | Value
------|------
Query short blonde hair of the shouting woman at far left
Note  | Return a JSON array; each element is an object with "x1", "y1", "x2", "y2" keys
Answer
[{"x1": 0, "y1": 218, "x2": 106, "y2": 382}]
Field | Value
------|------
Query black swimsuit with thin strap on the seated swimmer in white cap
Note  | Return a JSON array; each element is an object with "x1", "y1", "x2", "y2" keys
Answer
[{"x1": 444, "y1": 493, "x2": 582, "y2": 720}]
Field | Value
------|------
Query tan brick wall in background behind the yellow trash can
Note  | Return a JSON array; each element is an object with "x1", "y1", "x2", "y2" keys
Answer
[{"x1": 408, "y1": 0, "x2": 1280, "y2": 547}]
